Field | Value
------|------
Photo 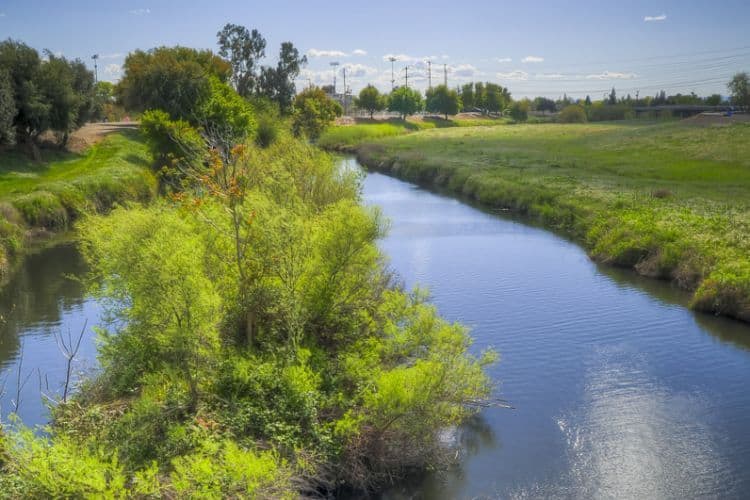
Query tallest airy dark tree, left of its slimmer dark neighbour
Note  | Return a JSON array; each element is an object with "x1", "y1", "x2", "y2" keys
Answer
[{"x1": 216, "y1": 23, "x2": 266, "y2": 98}]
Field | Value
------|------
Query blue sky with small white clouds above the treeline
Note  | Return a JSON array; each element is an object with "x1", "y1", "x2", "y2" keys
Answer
[{"x1": 0, "y1": 0, "x2": 750, "y2": 98}]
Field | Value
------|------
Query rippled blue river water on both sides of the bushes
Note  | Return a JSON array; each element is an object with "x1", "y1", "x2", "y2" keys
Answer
[{"x1": 0, "y1": 159, "x2": 750, "y2": 499}]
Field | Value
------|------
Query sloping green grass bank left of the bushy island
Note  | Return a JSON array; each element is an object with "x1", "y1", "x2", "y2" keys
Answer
[{"x1": 0, "y1": 129, "x2": 156, "y2": 282}]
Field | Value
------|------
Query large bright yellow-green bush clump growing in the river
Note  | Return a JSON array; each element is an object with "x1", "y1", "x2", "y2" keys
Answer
[{"x1": 2, "y1": 137, "x2": 495, "y2": 497}]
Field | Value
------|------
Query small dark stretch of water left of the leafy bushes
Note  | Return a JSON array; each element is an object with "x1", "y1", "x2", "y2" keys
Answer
[{"x1": 0, "y1": 245, "x2": 99, "y2": 425}]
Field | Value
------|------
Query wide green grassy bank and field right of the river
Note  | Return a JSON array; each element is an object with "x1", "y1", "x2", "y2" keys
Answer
[{"x1": 350, "y1": 122, "x2": 750, "y2": 321}]
